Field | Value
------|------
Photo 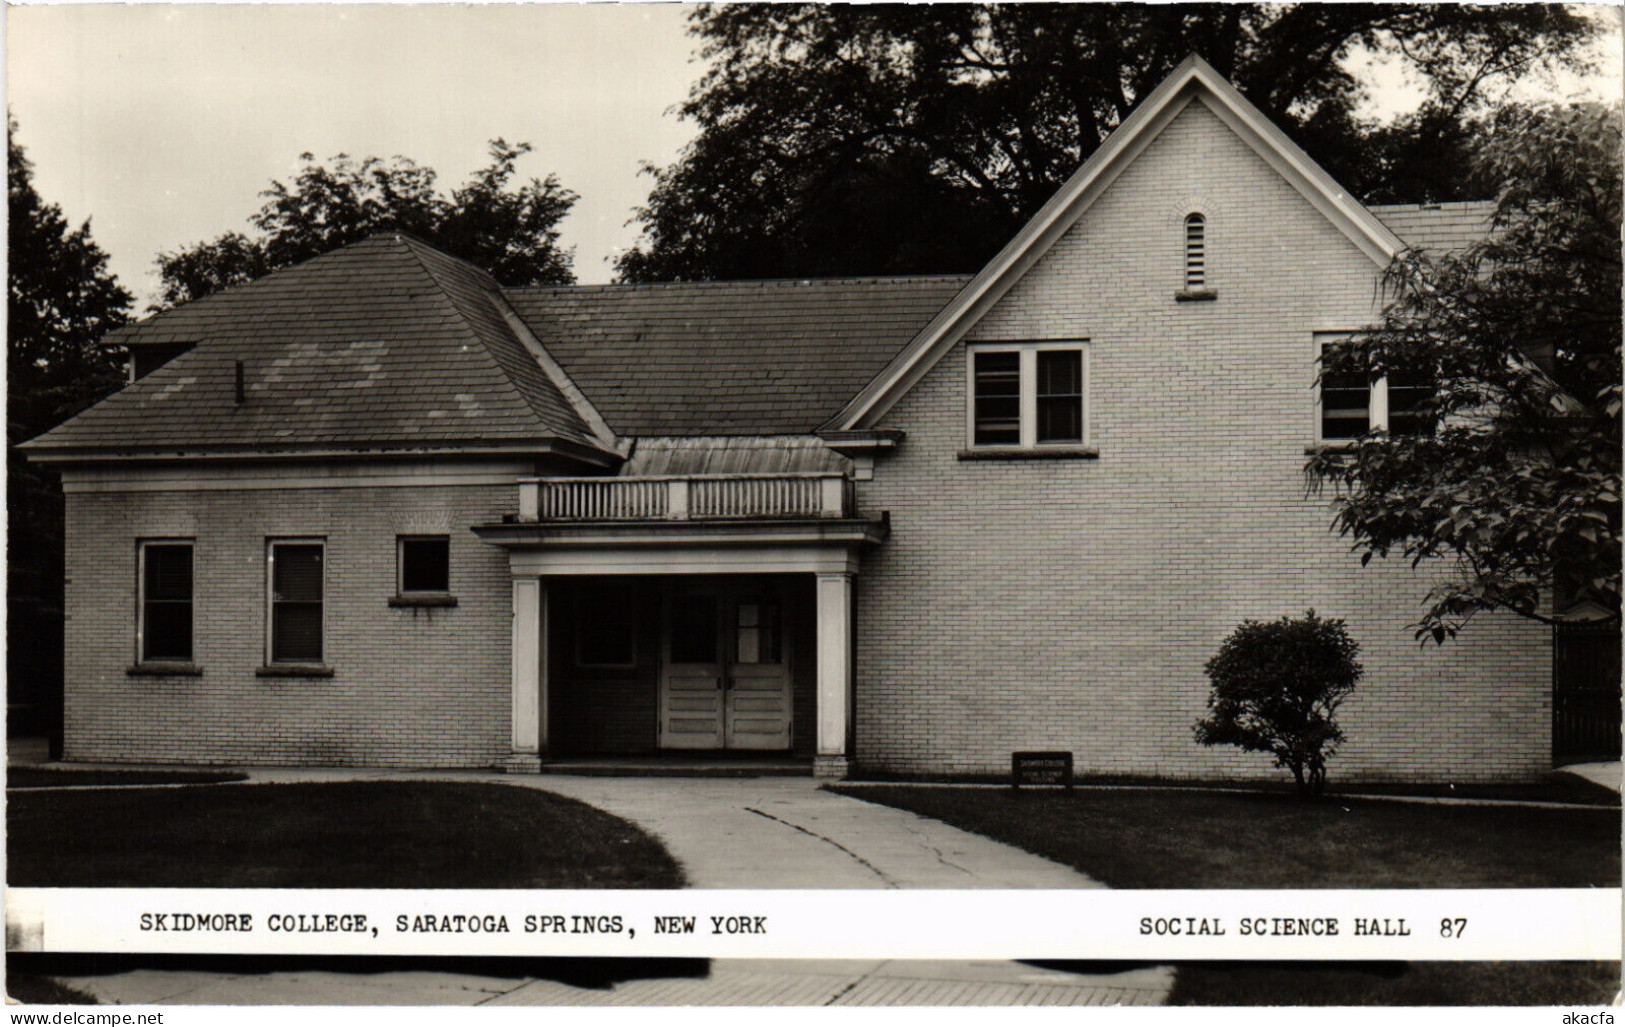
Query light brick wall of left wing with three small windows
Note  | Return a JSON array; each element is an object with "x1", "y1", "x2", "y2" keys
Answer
[{"x1": 65, "y1": 486, "x2": 514, "y2": 767}]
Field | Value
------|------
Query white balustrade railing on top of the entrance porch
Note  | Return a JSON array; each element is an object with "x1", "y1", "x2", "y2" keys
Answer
[{"x1": 518, "y1": 473, "x2": 853, "y2": 522}]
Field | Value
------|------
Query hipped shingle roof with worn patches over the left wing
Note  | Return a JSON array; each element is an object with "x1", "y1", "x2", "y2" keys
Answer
[{"x1": 24, "y1": 234, "x2": 618, "y2": 463}]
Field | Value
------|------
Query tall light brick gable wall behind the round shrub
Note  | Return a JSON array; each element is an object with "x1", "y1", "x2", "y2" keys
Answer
[{"x1": 856, "y1": 104, "x2": 1550, "y2": 780}]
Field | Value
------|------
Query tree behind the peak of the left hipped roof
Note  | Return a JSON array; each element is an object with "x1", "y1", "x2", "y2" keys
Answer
[{"x1": 158, "y1": 138, "x2": 577, "y2": 306}]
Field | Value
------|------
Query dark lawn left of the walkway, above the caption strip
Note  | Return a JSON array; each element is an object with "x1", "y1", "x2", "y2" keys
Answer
[{"x1": 7, "y1": 782, "x2": 683, "y2": 889}]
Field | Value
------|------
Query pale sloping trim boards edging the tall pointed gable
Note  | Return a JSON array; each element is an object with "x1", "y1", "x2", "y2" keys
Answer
[{"x1": 822, "y1": 55, "x2": 1404, "y2": 431}]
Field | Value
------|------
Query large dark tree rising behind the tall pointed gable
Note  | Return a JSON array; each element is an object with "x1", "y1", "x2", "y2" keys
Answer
[{"x1": 618, "y1": 3, "x2": 1594, "y2": 281}]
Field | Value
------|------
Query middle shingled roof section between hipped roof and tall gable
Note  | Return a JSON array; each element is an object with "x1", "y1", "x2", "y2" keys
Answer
[{"x1": 505, "y1": 276, "x2": 969, "y2": 436}]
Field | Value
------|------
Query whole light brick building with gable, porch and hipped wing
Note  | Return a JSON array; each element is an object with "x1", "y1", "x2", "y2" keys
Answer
[{"x1": 26, "y1": 59, "x2": 1552, "y2": 782}]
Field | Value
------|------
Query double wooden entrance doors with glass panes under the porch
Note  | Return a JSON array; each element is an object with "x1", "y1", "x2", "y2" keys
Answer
[{"x1": 660, "y1": 579, "x2": 791, "y2": 751}]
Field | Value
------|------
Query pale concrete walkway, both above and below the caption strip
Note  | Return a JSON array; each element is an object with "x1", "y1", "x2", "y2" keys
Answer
[{"x1": 28, "y1": 769, "x2": 1173, "y2": 1006}]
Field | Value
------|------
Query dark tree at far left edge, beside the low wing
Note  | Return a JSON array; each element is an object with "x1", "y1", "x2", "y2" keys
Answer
[{"x1": 7, "y1": 112, "x2": 132, "y2": 747}]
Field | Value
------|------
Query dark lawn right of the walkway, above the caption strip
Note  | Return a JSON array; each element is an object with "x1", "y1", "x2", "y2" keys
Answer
[{"x1": 834, "y1": 785, "x2": 1620, "y2": 889}]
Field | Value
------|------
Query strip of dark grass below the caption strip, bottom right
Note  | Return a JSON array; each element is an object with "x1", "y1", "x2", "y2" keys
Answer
[{"x1": 1168, "y1": 962, "x2": 1620, "y2": 1022}]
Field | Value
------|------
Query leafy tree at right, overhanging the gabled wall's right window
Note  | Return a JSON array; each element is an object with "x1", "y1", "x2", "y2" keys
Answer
[{"x1": 1305, "y1": 104, "x2": 1622, "y2": 642}]
